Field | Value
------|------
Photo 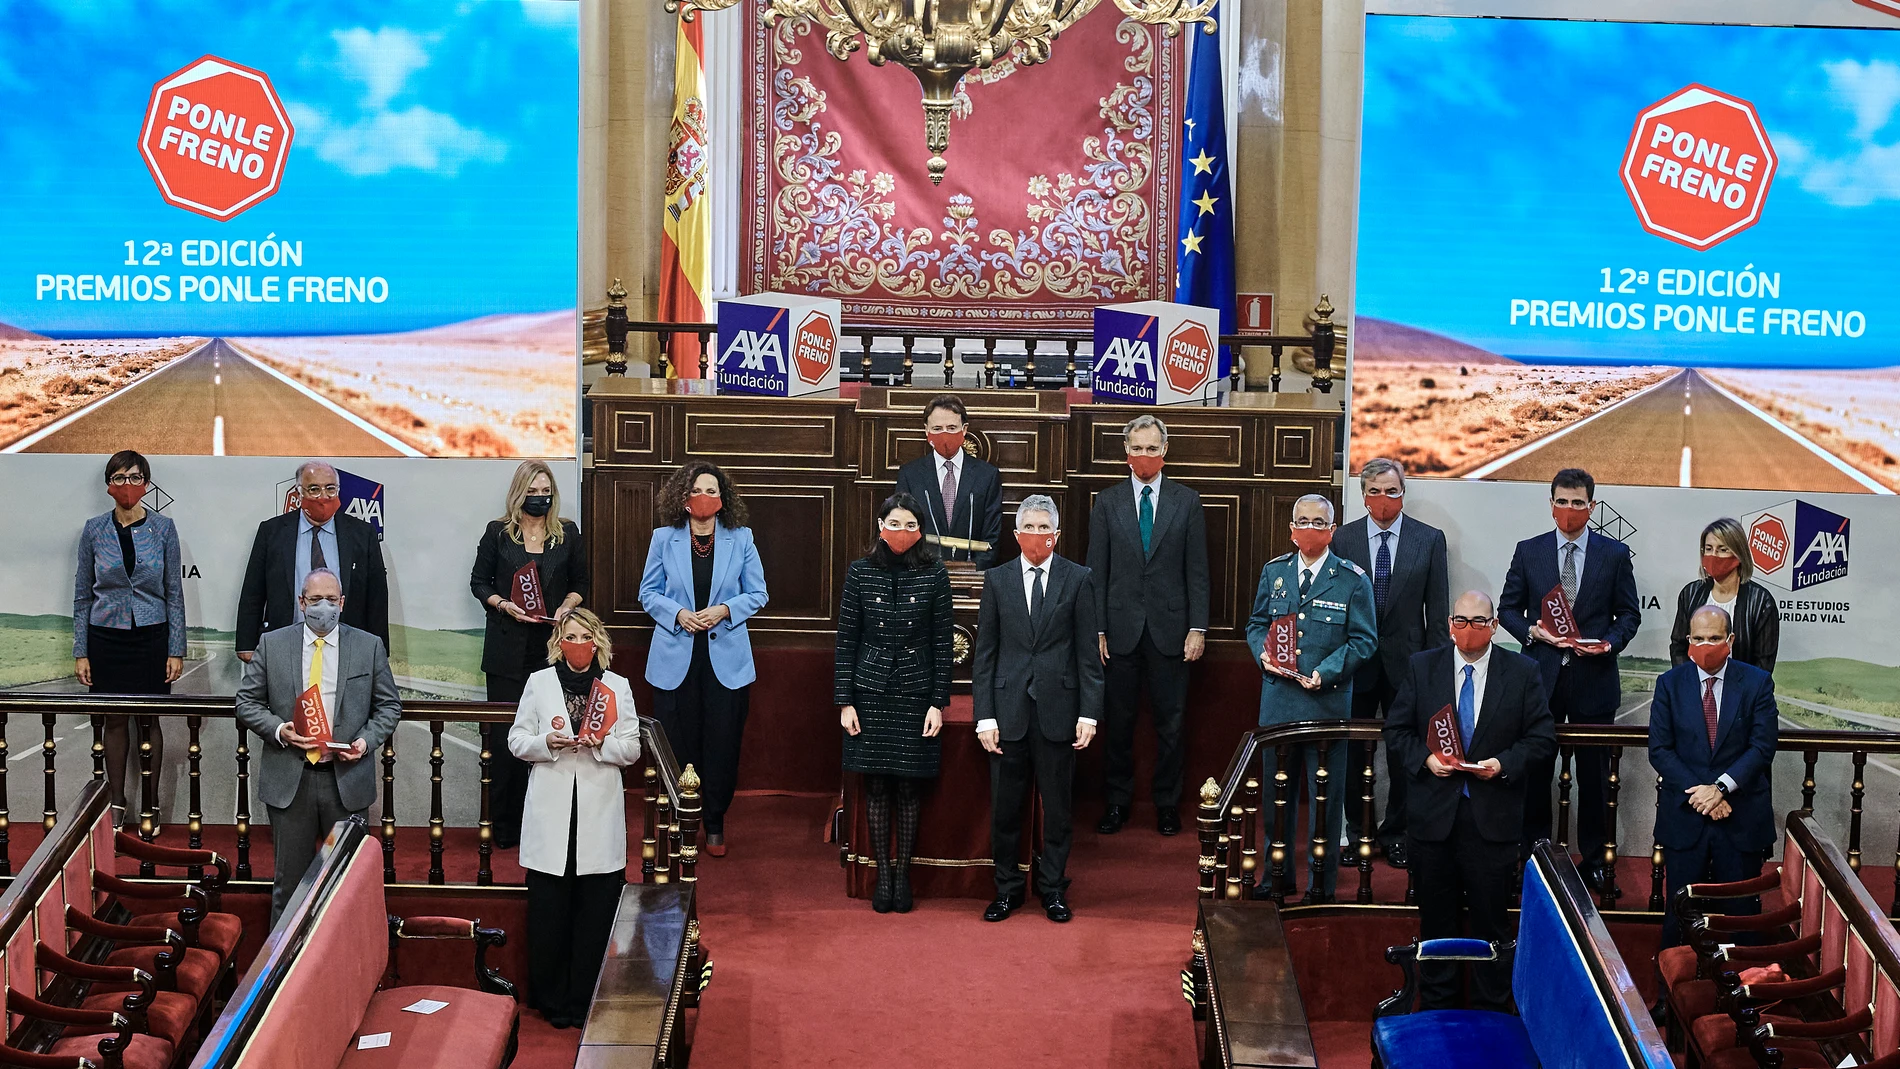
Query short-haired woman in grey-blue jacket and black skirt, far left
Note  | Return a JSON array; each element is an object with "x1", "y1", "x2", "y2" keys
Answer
[{"x1": 72, "y1": 450, "x2": 186, "y2": 824}]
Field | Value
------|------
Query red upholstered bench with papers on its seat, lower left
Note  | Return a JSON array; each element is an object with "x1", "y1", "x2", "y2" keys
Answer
[{"x1": 192, "y1": 818, "x2": 521, "y2": 1069}]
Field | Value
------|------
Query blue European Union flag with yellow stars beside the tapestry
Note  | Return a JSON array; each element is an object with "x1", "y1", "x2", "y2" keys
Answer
[{"x1": 1174, "y1": 4, "x2": 1239, "y2": 376}]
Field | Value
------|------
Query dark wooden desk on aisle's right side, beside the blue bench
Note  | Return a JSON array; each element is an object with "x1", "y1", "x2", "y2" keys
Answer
[{"x1": 1184, "y1": 898, "x2": 1319, "y2": 1069}]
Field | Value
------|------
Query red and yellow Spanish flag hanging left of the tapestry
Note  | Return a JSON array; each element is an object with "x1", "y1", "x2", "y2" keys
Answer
[{"x1": 659, "y1": 19, "x2": 713, "y2": 378}]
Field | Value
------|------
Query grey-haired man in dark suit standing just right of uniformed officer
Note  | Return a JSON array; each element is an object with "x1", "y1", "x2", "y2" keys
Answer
[{"x1": 1332, "y1": 456, "x2": 1452, "y2": 868}]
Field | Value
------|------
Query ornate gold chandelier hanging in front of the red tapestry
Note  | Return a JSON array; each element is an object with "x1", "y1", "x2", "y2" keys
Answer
[{"x1": 665, "y1": 0, "x2": 1216, "y2": 184}]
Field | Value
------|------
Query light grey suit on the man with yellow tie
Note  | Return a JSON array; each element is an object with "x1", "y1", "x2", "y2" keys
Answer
[{"x1": 238, "y1": 625, "x2": 403, "y2": 925}]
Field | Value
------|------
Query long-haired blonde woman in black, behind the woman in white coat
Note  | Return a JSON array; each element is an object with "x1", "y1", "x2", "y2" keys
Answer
[{"x1": 469, "y1": 459, "x2": 587, "y2": 849}]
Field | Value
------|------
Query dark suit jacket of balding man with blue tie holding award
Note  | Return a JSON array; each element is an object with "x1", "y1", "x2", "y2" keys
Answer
[{"x1": 1385, "y1": 645, "x2": 1556, "y2": 843}]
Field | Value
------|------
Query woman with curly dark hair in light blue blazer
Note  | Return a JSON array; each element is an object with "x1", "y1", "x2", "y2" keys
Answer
[{"x1": 640, "y1": 461, "x2": 766, "y2": 858}]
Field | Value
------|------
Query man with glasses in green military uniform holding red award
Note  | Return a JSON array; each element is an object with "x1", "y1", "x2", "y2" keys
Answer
[{"x1": 1246, "y1": 494, "x2": 1379, "y2": 906}]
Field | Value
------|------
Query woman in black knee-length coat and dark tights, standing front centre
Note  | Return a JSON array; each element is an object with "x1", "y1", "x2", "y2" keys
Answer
[{"x1": 836, "y1": 494, "x2": 954, "y2": 913}]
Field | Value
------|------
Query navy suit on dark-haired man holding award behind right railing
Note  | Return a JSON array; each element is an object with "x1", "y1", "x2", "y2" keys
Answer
[{"x1": 1497, "y1": 532, "x2": 1644, "y2": 858}]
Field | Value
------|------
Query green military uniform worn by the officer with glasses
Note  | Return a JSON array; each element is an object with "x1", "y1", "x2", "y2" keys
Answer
[{"x1": 1246, "y1": 551, "x2": 1379, "y2": 898}]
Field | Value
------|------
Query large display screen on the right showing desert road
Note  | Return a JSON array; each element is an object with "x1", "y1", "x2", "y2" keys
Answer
[{"x1": 1351, "y1": 15, "x2": 1900, "y2": 494}]
